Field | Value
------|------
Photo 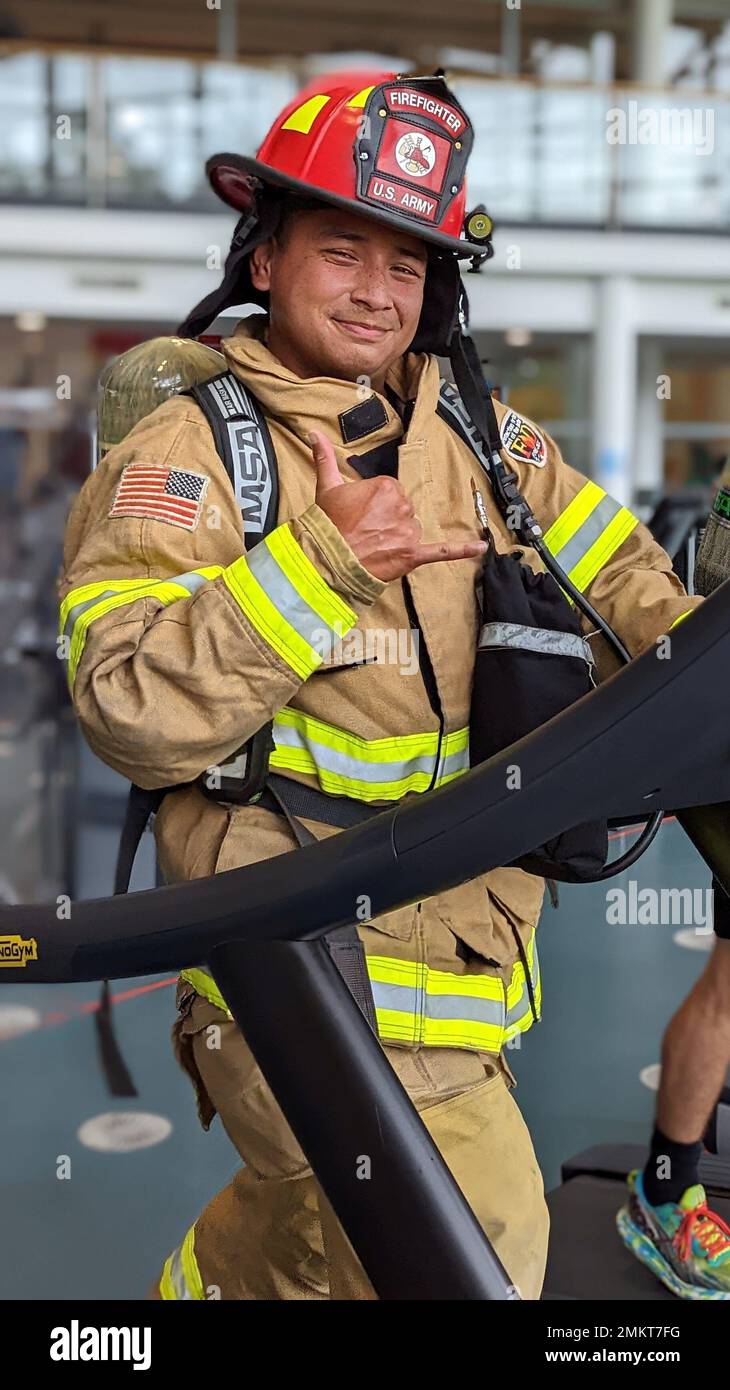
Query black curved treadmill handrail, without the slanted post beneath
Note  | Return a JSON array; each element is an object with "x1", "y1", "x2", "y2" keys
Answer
[{"x1": 0, "y1": 569, "x2": 730, "y2": 984}]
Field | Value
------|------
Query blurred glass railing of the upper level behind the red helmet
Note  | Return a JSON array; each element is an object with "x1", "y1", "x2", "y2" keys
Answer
[{"x1": 0, "y1": 51, "x2": 730, "y2": 231}]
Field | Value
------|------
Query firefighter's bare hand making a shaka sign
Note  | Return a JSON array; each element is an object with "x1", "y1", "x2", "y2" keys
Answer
[{"x1": 304, "y1": 431, "x2": 487, "y2": 582}]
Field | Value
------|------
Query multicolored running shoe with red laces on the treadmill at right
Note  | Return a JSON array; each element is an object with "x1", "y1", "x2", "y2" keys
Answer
[{"x1": 616, "y1": 1169, "x2": 730, "y2": 1300}]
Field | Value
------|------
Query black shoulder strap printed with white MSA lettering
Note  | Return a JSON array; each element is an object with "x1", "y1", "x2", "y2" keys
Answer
[{"x1": 185, "y1": 371, "x2": 279, "y2": 550}]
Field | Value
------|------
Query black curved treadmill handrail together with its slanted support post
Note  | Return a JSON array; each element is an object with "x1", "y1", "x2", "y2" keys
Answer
[{"x1": 0, "y1": 582, "x2": 730, "y2": 1300}]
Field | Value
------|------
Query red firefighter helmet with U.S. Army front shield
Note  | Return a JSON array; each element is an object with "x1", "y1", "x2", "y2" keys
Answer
[{"x1": 206, "y1": 72, "x2": 492, "y2": 257}]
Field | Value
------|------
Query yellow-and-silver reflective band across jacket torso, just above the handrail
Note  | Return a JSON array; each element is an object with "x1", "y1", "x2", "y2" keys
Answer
[{"x1": 270, "y1": 706, "x2": 469, "y2": 802}]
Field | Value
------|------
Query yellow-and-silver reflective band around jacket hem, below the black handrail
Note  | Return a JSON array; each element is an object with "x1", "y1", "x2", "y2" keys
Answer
[{"x1": 367, "y1": 933, "x2": 541, "y2": 1052}]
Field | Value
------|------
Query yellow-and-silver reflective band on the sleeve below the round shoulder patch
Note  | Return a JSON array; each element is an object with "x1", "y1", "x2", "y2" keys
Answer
[{"x1": 544, "y1": 482, "x2": 638, "y2": 594}]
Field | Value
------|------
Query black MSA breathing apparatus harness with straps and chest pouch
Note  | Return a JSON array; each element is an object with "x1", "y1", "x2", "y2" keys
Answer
[{"x1": 115, "y1": 371, "x2": 620, "y2": 892}]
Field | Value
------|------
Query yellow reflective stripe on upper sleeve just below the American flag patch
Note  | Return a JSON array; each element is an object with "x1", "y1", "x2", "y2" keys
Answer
[{"x1": 60, "y1": 564, "x2": 222, "y2": 687}]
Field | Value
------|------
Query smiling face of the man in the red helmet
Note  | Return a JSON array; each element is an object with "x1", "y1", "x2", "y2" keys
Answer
[{"x1": 250, "y1": 209, "x2": 427, "y2": 389}]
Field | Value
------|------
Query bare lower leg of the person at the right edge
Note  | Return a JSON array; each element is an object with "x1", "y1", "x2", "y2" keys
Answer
[{"x1": 656, "y1": 940, "x2": 730, "y2": 1144}]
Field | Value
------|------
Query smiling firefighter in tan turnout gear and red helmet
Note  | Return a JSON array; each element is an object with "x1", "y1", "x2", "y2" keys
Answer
[{"x1": 61, "y1": 74, "x2": 694, "y2": 1300}]
